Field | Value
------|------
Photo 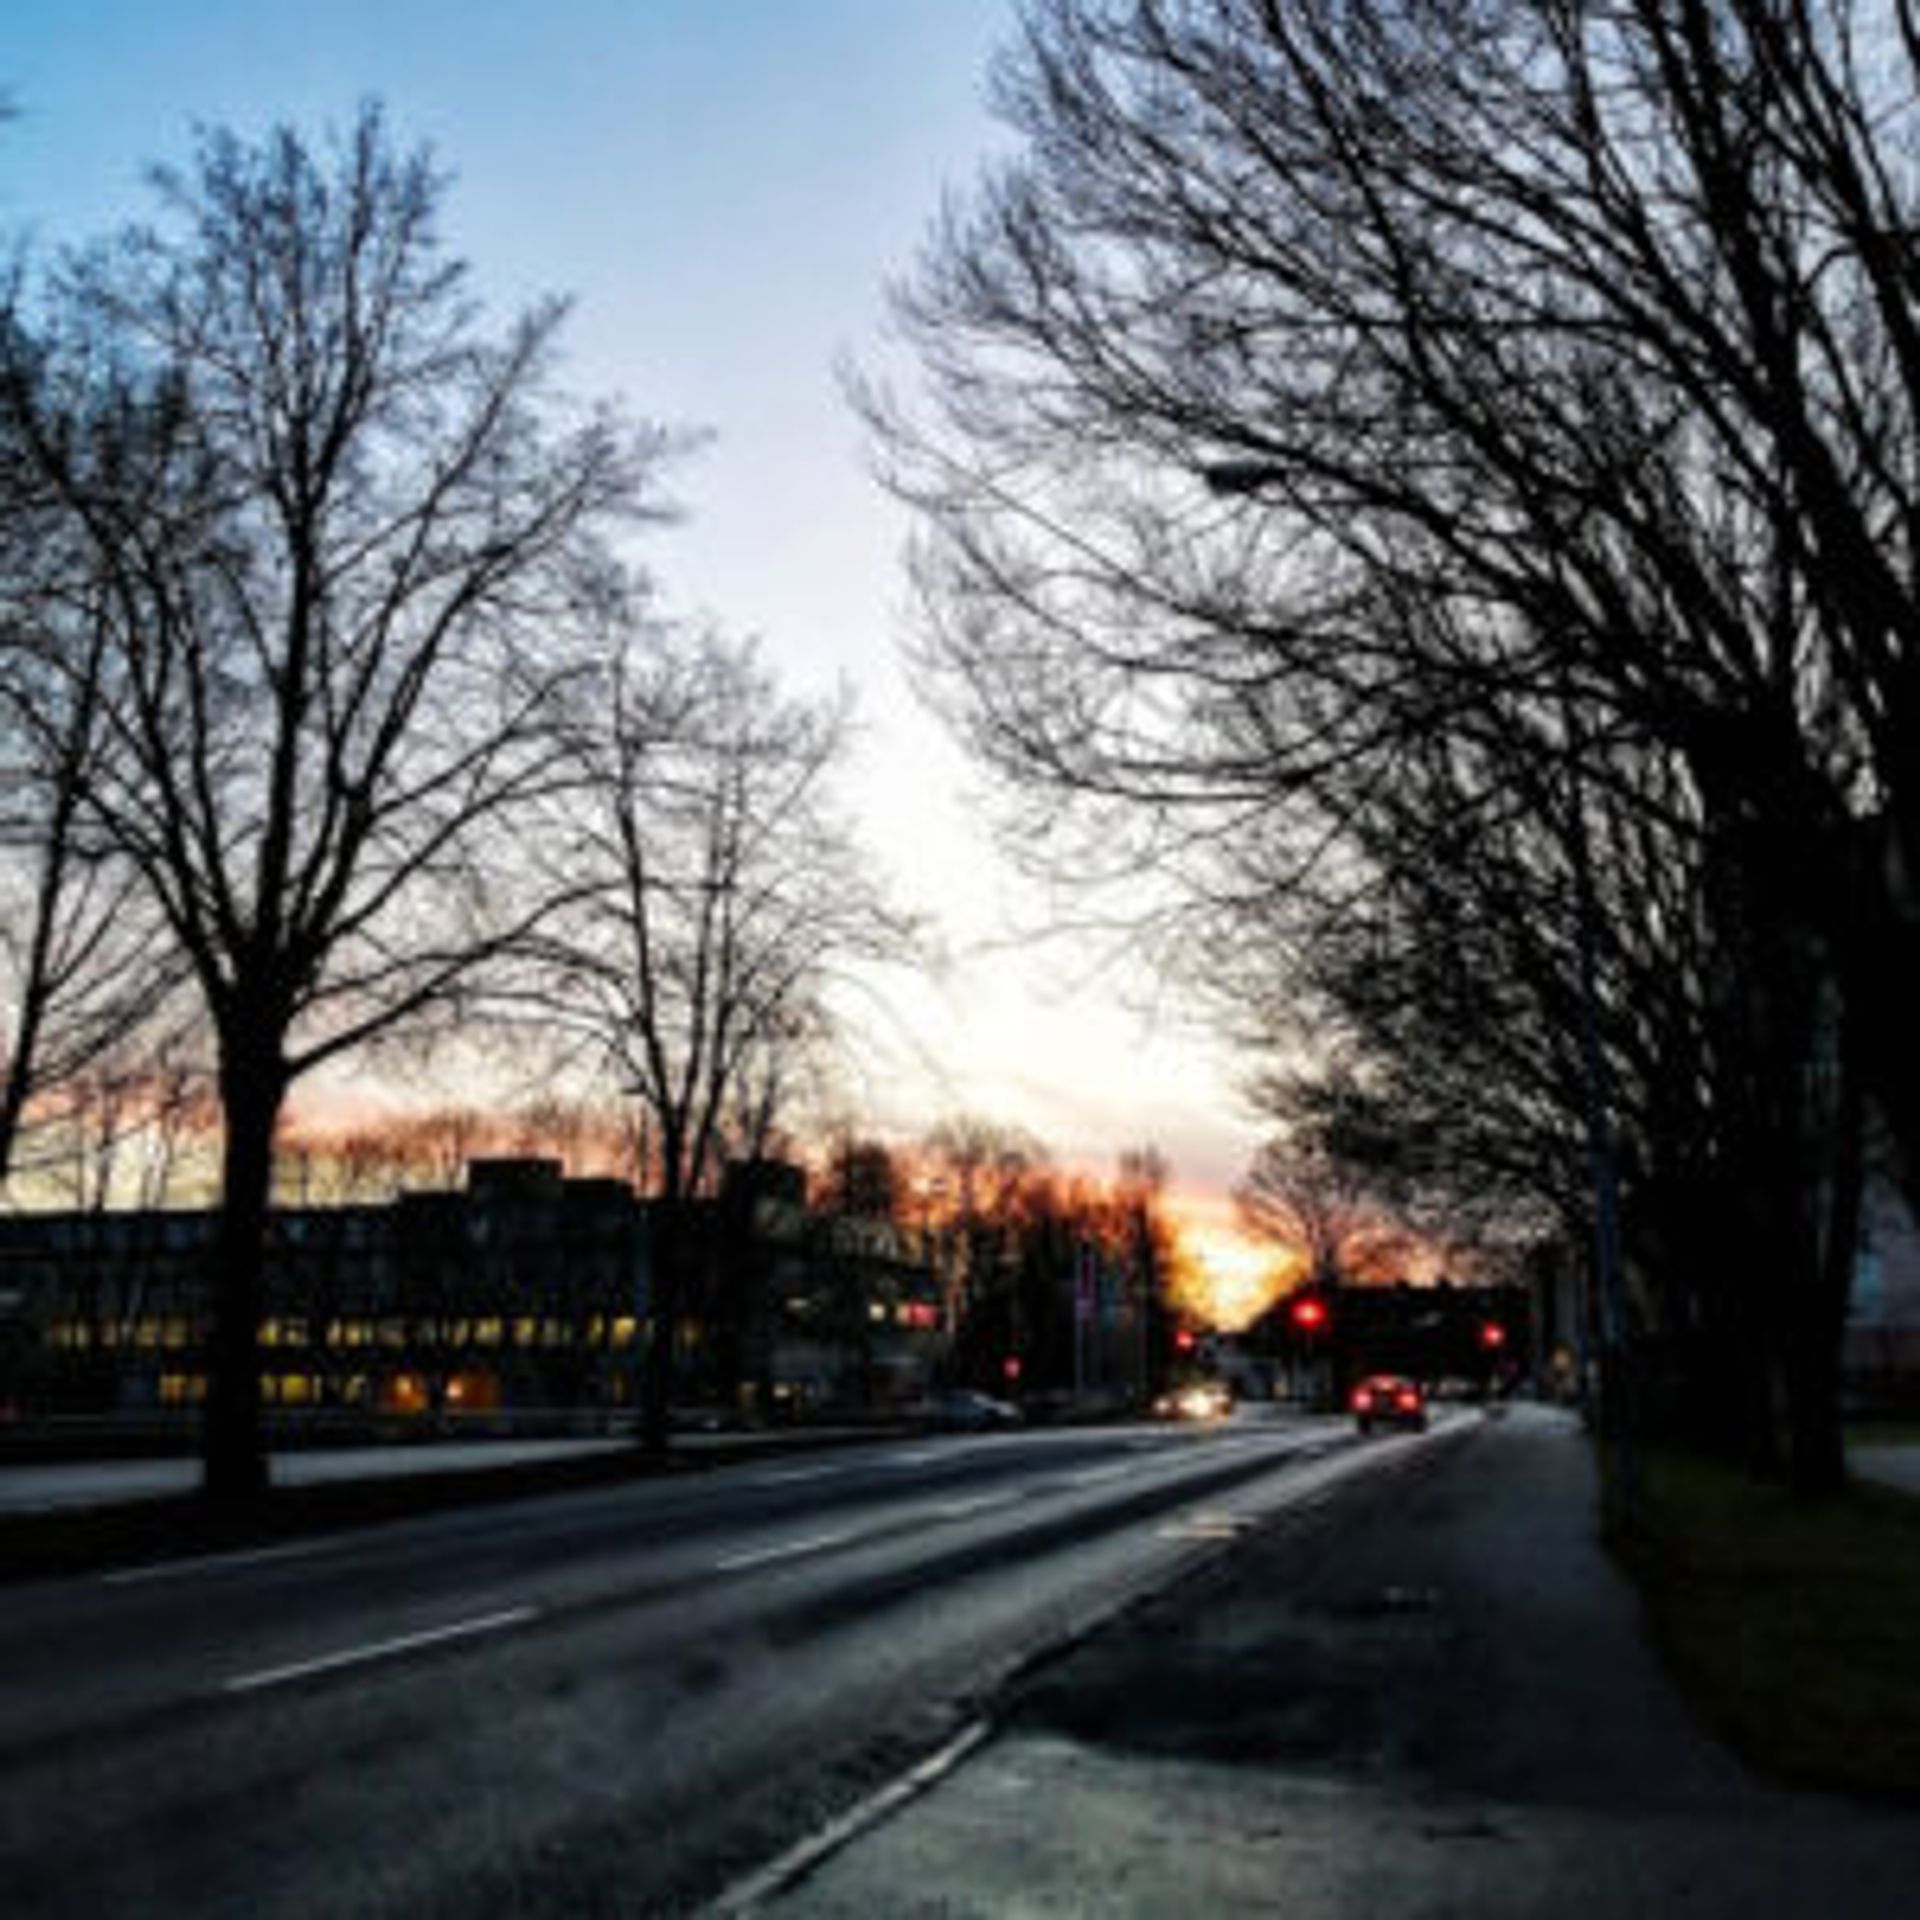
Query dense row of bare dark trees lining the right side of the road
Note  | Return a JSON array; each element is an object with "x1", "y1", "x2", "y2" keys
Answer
[{"x1": 864, "y1": 0, "x2": 1920, "y2": 1490}]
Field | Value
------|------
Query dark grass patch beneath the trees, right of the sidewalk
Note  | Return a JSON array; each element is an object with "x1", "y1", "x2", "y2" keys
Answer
[{"x1": 1622, "y1": 1452, "x2": 1920, "y2": 1801}]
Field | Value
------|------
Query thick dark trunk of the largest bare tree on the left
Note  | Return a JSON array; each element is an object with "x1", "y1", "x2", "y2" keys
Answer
[{"x1": 202, "y1": 1039, "x2": 286, "y2": 1505}]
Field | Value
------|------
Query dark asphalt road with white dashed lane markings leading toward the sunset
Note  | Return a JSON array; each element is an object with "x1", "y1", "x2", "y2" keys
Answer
[{"x1": 0, "y1": 1417, "x2": 1432, "y2": 1916}]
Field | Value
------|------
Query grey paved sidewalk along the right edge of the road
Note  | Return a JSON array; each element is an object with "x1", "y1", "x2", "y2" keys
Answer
[{"x1": 744, "y1": 1409, "x2": 1920, "y2": 1920}]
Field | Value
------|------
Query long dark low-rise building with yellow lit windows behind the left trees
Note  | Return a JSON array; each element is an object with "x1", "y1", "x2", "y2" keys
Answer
[{"x1": 0, "y1": 1160, "x2": 947, "y2": 1430}]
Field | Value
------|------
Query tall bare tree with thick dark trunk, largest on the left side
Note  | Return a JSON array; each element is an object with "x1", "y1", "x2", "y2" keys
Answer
[{"x1": 0, "y1": 109, "x2": 660, "y2": 1498}]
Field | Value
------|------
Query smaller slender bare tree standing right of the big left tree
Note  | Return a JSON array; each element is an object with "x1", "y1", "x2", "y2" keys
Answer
[{"x1": 541, "y1": 636, "x2": 910, "y2": 1448}]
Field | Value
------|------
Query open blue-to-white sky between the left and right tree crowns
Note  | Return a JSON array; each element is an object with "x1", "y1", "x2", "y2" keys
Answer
[{"x1": 0, "y1": 0, "x2": 1290, "y2": 1320}]
